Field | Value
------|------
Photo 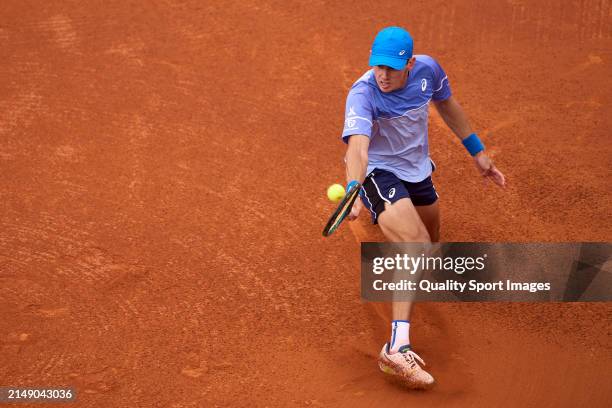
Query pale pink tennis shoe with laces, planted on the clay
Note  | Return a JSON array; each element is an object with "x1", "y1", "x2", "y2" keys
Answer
[{"x1": 378, "y1": 343, "x2": 435, "y2": 389}]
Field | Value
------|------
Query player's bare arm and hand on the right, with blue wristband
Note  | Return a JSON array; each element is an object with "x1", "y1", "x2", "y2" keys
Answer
[{"x1": 433, "y1": 96, "x2": 506, "y2": 187}]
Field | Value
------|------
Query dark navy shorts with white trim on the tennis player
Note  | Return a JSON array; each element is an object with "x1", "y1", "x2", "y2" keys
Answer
[{"x1": 359, "y1": 169, "x2": 438, "y2": 224}]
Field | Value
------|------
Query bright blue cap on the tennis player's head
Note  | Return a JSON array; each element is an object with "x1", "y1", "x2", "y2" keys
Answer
[{"x1": 370, "y1": 27, "x2": 413, "y2": 70}]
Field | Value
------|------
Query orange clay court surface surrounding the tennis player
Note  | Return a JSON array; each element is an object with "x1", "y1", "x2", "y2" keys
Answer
[{"x1": 0, "y1": 0, "x2": 612, "y2": 407}]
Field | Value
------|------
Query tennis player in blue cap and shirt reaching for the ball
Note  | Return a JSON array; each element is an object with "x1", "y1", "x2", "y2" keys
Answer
[{"x1": 342, "y1": 27, "x2": 505, "y2": 388}]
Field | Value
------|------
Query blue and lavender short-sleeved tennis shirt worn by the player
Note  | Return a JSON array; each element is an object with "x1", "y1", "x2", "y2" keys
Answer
[{"x1": 342, "y1": 55, "x2": 451, "y2": 183}]
